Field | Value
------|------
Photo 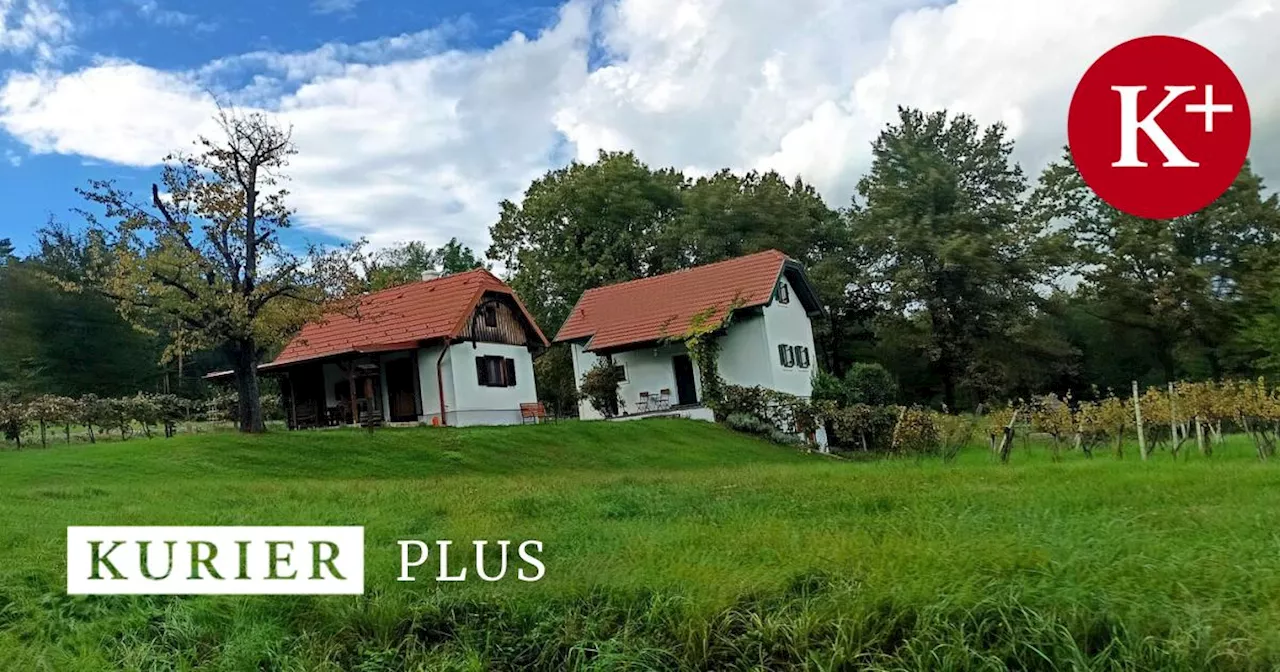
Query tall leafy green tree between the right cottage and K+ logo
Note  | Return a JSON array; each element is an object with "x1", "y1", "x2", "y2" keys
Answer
[{"x1": 847, "y1": 109, "x2": 1056, "y2": 408}]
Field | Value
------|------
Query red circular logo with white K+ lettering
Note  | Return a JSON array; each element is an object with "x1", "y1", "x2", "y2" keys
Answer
[{"x1": 1066, "y1": 36, "x2": 1251, "y2": 219}]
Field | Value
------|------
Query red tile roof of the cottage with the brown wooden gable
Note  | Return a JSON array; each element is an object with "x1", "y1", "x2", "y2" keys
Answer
[{"x1": 264, "y1": 269, "x2": 547, "y2": 367}]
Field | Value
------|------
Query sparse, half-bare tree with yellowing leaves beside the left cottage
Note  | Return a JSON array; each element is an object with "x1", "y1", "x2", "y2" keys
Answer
[{"x1": 70, "y1": 111, "x2": 357, "y2": 431}]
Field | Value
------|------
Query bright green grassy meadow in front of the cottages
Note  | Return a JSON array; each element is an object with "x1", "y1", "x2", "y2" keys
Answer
[{"x1": 0, "y1": 420, "x2": 1280, "y2": 672}]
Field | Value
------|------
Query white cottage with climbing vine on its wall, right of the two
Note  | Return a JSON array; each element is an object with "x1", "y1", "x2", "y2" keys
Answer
[{"x1": 556, "y1": 250, "x2": 823, "y2": 420}]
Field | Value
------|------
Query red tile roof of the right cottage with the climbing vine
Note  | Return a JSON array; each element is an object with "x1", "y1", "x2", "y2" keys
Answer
[{"x1": 556, "y1": 250, "x2": 787, "y2": 351}]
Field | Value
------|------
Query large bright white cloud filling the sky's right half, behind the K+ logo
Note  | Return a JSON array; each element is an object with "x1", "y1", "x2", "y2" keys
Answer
[{"x1": 557, "y1": 0, "x2": 1280, "y2": 205}]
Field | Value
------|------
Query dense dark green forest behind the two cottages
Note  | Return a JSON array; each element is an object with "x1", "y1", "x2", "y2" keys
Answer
[{"x1": 0, "y1": 109, "x2": 1280, "y2": 410}]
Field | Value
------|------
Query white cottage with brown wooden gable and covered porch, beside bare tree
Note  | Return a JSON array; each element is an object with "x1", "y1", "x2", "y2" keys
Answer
[{"x1": 259, "y1": 269, "x2": 548, "y2": 428}]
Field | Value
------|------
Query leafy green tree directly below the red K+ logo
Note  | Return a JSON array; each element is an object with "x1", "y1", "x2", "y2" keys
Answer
[{"x1": 1032, "y1": 155, "x2": 1280, "y2": 381}]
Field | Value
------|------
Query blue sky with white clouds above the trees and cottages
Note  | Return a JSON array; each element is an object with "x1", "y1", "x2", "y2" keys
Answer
[{"x1": 0, "y1": 0, "x2": 1280, "y2": 257}]
